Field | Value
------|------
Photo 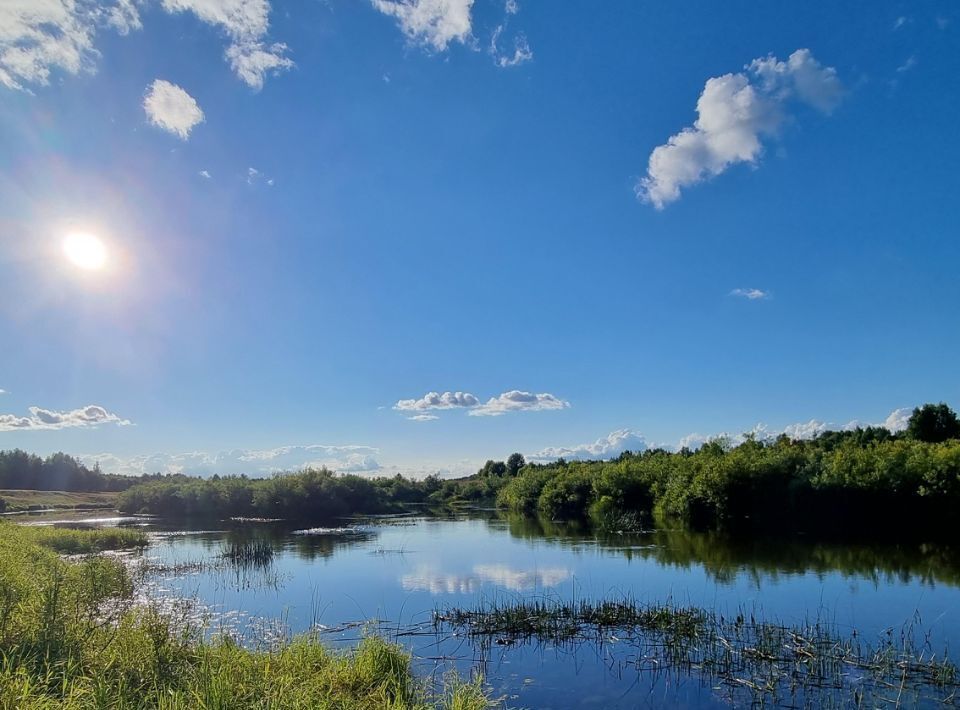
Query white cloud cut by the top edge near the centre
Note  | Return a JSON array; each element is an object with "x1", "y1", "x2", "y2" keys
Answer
[{"x1": 371, "y1": 0, "x2": 473, "y2": 52}]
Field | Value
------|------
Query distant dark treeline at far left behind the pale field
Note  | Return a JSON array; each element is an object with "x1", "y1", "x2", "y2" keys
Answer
[{"x1": 0, "y1": 449, "x2": 159, "y2": 493}]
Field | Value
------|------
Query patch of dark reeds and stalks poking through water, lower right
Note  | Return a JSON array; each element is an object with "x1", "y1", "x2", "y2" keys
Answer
[{"x1": 434, "y1": 600, "x2": 960, "y2": 707}]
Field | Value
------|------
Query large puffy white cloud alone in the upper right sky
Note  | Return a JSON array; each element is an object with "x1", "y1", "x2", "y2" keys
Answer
[{"x1": 636, "y1": 49, "x2": 843, "y2": 209}]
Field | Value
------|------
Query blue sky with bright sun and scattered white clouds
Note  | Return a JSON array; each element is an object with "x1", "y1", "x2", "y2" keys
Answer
[{"x1": 0, "y1": 0, "x2": 960, "y2": 476}]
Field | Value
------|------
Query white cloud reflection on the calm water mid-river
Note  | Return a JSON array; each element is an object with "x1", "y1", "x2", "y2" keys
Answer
[{"x1": 400, "y1": 565, "x2": 570, "y2": 594}]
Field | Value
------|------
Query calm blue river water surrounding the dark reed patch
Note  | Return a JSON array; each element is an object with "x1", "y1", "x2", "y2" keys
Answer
[{"x1": 45, "y1": 512, "x2": 960, "y2": 708}]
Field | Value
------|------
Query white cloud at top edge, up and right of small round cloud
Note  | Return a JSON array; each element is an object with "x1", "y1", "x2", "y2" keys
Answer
[{"x1": 162, "y1": 0, "x2": 293, "y2": 89}]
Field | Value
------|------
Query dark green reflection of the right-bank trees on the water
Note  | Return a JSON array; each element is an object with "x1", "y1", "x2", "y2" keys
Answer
[{"x1": 499, "y1": 515, "x2": 960, "y2": 586}]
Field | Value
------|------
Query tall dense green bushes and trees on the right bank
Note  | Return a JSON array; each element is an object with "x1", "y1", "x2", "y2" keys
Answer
[{"x1": 496, "y1": 404, "x2": 960, "y2": 531}]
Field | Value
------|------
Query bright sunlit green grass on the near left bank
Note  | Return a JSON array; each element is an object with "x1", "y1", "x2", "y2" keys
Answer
[{"x1": 0, "y1": 522, "x2": 488, "y2": 710}]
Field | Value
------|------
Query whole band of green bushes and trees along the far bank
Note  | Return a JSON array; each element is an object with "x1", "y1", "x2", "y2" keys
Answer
[{"x1": 109, "y1": 404, "x2": 960, "y2": 530}]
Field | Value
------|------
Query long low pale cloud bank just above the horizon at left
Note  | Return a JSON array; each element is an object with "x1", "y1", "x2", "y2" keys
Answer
[{"x1": 81, "y1": 444, "x2": 380, "y2": 476}]
